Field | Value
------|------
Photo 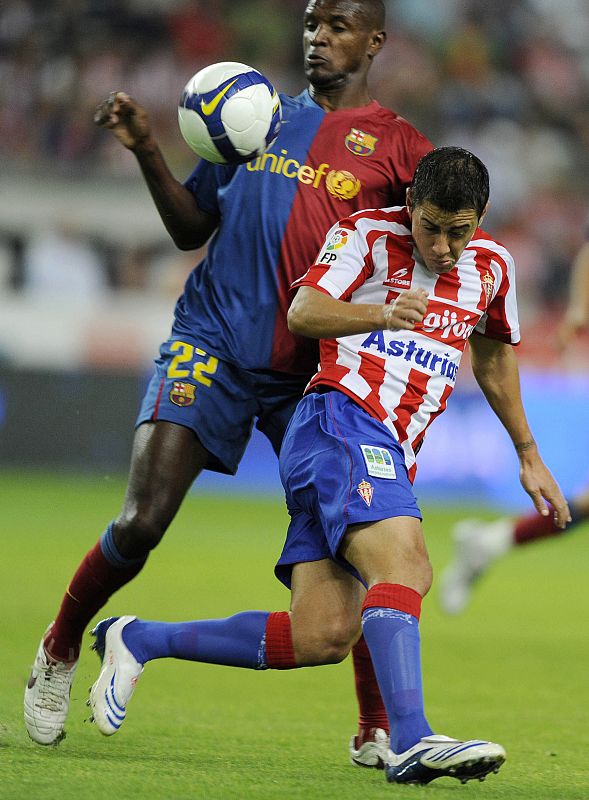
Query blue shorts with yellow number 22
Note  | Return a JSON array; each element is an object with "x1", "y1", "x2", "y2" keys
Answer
[{"x1": 136, "y1": 337, "x2": 309, "y2": 475}]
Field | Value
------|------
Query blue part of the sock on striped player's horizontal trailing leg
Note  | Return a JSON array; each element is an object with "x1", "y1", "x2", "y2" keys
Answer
[{"x1": 123, "y1": 611, "x2": 269, "y2": 669}]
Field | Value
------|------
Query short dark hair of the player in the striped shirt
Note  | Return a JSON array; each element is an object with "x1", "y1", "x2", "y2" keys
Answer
[{"x1": 411, "y1": 147, "x2": 489, "y2": 217}]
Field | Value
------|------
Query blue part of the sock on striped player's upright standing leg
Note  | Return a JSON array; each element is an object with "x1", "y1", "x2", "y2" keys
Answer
[{"x1": 362, "y1": 607, "x2": 432, "y2": 754}]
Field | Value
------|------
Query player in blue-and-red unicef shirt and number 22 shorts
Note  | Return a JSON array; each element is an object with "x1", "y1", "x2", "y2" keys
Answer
[{"x1": 25, "y1": 0, "x2": 431, "y2": 766}]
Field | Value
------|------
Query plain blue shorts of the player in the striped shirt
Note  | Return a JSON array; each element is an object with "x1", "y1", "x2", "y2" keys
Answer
[{"x1": 274, "y1": 391, "x2": 421, "y2": 587}]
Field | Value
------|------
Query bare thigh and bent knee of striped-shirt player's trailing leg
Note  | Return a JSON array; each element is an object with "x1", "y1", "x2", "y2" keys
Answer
[{"x1": 290, "y1": 559, "x2": 366, "y2": 663}]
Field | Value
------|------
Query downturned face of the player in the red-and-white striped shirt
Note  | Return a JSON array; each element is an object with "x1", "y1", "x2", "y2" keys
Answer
[{"x1": 407, "y1": 201, "x2": 480, "y2": 275}]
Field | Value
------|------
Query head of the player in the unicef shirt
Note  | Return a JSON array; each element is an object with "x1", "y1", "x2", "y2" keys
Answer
[{"x1": 303, "y1": 0, "x2": 384, "y2": 87}]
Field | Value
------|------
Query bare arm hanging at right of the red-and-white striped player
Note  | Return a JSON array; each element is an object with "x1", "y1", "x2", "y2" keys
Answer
[{"x1": 470, "y1": 333, "x2": 571, "y2": 528}]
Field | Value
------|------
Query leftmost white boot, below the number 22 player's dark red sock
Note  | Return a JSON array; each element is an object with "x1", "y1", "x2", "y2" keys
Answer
[{"x1": 24, "y1": 623, "x2": 78, "y2": 745}]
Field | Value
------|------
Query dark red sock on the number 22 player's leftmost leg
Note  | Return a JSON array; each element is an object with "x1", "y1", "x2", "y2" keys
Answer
[{"x1": 45, "y1": 542, "x2": 145, "y2": 661}]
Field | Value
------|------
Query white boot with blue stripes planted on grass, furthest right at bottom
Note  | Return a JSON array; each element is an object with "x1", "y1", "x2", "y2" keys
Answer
[{"x1": 386, "y1": 735, "x2": 506, "y2": 785}]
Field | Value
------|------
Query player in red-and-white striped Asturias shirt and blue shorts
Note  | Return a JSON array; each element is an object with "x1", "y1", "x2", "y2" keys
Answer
[{"x1": 90, "y1": 147, "x2": 570, "y2": 784}]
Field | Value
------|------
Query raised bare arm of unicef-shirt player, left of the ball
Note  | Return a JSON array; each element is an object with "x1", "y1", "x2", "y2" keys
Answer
[{"x1": 94, "y1": 92, "x2": 219, "y2": 250}]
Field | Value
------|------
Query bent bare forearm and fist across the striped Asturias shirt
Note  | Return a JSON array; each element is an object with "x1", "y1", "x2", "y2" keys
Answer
[{"x1": 288, "y1": 286, "x2": 427, "y2": 339}]
